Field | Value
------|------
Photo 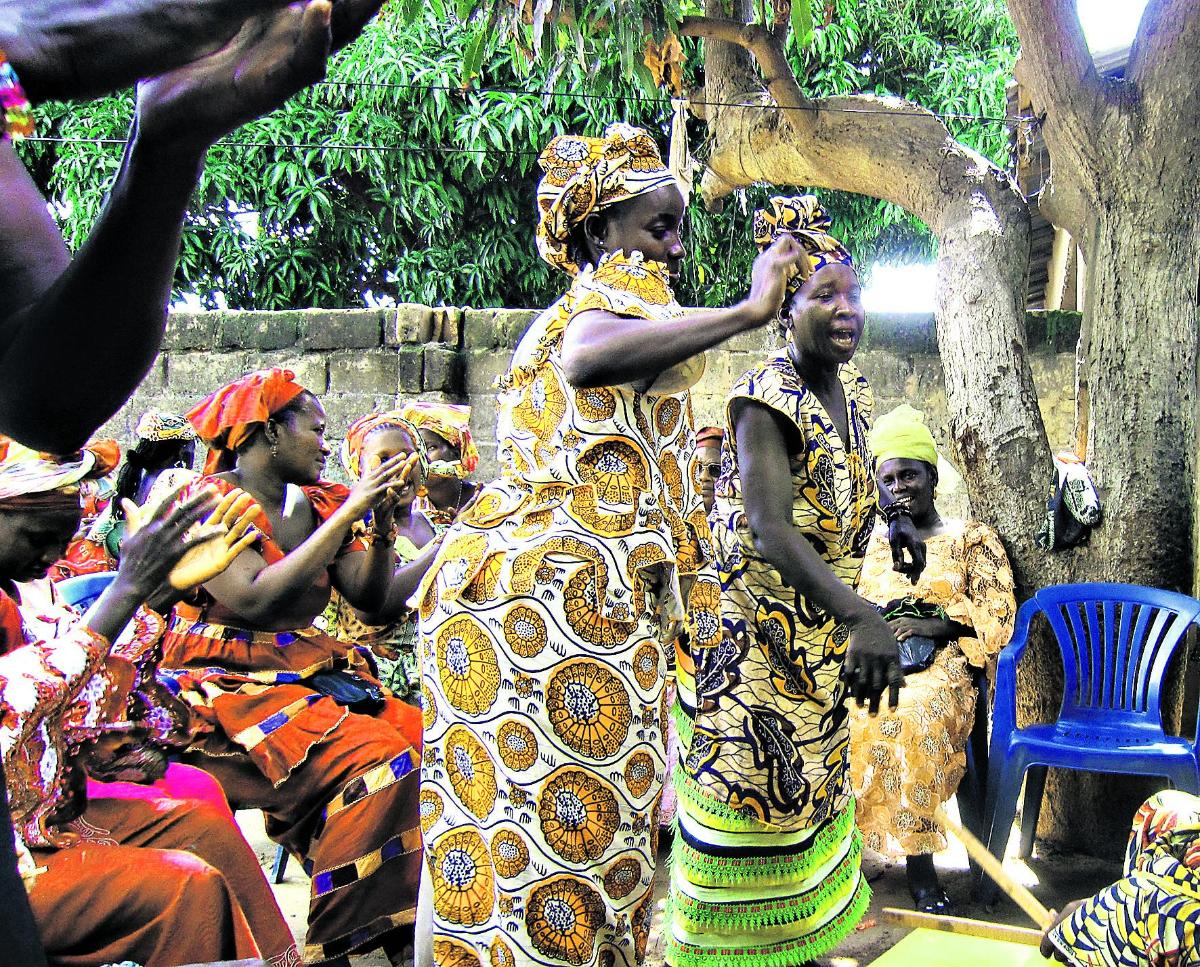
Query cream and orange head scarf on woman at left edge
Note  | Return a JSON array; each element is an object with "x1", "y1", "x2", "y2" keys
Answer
[{"x1": 0, "y1": 436, "x2": 121, "y2": 511}]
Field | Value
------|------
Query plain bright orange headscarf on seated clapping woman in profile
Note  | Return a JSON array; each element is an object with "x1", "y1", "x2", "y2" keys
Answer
[{"x1": 187, "y1": 367, "x2": 305, "y2": 474}]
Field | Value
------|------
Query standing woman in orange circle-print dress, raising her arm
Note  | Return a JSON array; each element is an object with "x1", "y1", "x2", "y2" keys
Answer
[{"x1": 418, "y1": 125, "x2": 799, "y2": 967}]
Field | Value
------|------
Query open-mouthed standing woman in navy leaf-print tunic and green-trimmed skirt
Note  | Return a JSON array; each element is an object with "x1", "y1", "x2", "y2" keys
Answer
[{"x1": 667, "y1": 196, "x2": 924, "y2": 967}]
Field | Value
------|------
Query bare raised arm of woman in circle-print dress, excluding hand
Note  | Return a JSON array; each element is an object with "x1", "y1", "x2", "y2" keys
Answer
[{"x1": 563, "y1": 305, "x2": 761, "y2": 389}]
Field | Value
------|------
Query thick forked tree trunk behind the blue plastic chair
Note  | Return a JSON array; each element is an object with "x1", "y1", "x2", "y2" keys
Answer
[{"x1": 1008, "y1": 0, "x2": 1200, "y2": 853}]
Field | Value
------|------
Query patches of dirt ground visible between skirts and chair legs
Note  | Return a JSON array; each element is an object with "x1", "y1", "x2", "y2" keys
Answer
[{"x1": 238, "y1": 796, "x2": 1121, "y2": 967}]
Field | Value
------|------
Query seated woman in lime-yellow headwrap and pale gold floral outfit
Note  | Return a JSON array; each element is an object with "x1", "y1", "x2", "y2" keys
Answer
[{"x1": 850, "y1": 406, "x2": 1016, "y2": 913}]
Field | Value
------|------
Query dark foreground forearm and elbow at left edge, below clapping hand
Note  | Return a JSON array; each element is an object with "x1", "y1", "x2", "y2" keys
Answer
[{"x1": 0, "y1": 124, "x2": 203, "y2": 452}]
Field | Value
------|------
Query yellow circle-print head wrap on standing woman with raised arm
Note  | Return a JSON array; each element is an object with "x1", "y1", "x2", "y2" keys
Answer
[{"x1": 538, "y1": 122, "x2": 677, "y2": 275}]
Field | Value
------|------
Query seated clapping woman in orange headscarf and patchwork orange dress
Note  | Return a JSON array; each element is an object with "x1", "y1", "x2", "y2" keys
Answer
[{"x1": 162, "y1": 368, "x2": 421, "y2": 963}]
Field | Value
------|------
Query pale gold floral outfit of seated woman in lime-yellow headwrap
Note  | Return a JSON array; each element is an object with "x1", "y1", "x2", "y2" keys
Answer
[{"x1": 850, "y1": 521, "x2": 1016, "y2": 857}]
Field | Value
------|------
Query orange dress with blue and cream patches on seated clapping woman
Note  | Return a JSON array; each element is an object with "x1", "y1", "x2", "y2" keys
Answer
[{"x1": 161, "y1": 478, "x2": 421, "y2": 963}]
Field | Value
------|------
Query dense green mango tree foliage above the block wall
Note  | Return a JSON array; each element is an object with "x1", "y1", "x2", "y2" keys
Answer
[{"x1": 16, "y1": 0, "x2": 1013, "y2": 308}]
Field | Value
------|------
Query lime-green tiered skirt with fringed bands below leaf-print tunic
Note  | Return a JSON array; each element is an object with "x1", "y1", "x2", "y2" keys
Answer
[{"x1": 665, "y1": 795, "x2": 871, "y2": 967}]
